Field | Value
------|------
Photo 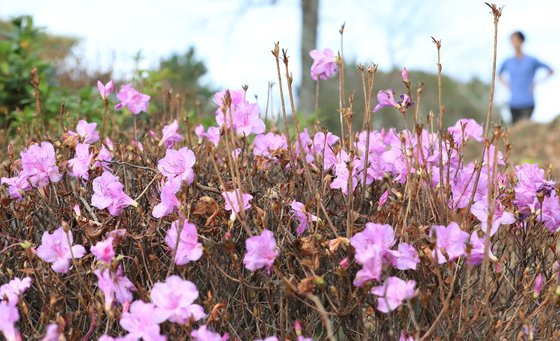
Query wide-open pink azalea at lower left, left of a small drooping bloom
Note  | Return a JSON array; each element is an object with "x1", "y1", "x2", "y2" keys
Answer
[{"x1": 37, "y1": 226, "x2": 86, "y2": 274}]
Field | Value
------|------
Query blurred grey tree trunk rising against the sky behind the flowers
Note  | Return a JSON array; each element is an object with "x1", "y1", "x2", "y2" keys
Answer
[{"x1": 298, "y1": 0, "x2": 319, "y2": 117}]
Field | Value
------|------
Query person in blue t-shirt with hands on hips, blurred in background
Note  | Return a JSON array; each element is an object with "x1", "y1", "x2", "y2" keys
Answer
[{"x1": 498, "y1": 31, "x2": 554, "y2": 124}]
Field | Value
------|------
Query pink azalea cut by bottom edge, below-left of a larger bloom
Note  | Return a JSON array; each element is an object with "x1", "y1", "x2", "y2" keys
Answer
[{"x1": 120, "y1": 301, "x2": 166, "y2": 341}]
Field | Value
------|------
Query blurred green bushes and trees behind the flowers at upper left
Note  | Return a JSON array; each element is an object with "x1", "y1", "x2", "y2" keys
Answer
[{"x1": 0, "y1": 16, "x2": 214, "y2": 134}]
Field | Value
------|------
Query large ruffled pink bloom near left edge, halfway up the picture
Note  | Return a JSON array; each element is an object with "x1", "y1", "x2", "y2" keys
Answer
[{"x1": 20, "y1": 142, "x2": 61, "y2": 188}]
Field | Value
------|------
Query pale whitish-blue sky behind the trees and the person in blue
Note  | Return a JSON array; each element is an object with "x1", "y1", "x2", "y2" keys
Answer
[{"x1": 0, "y1": 0, "x2": 560, "y2": 122}]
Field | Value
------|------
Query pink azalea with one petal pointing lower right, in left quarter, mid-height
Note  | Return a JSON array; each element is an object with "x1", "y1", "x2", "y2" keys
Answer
[{"x1": 91, "y1": 171, "x2": 137, "y2": 216}]
